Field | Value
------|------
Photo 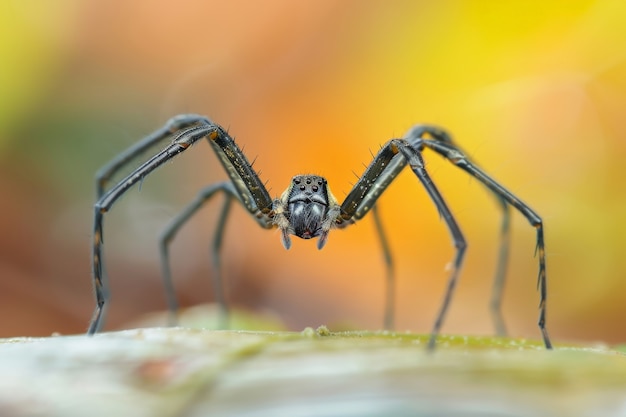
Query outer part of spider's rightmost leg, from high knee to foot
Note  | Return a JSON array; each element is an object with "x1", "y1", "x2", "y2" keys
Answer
[{"x1": 422, "y1": 140, "x2": 552, "y2": 349}]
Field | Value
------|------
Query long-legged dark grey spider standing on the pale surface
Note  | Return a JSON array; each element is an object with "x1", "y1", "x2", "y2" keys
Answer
[{"x1": 88, "y1": 114, "x2": 552, "y2": 349}]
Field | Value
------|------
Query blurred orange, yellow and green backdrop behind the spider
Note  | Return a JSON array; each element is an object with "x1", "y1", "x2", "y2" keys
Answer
[{"x1": 0, "y1": 0, "x2": 626, "y2": 343}]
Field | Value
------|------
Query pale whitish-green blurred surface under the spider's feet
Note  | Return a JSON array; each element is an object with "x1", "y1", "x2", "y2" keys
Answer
[{"x1": 0, "y1": 327, "x2": 626, "y2": 417}]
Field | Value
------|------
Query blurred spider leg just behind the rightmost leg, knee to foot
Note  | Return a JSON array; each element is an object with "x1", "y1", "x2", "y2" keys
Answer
[{"x1": 405, "y1": 125, "x2": 511, "y2": 336}]
